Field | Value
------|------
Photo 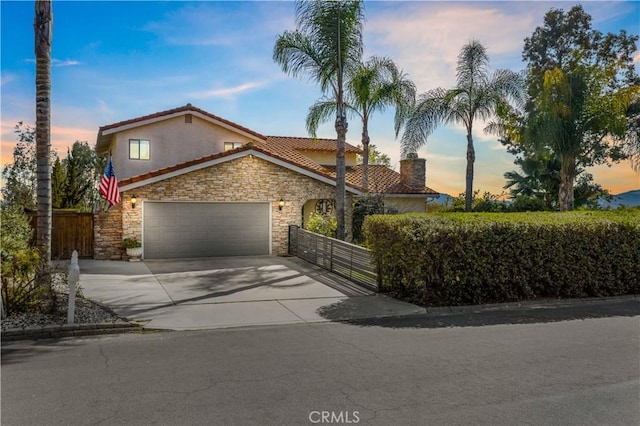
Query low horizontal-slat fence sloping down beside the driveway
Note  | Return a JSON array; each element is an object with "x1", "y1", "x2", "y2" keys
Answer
[{"x1": 289, "y1": 225, "x2": 378, "y2": 292}]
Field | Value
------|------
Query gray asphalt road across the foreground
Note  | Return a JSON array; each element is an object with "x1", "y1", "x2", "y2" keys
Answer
[{"x1": 1, "y1": 304, "x2": 640, "y2": 425}]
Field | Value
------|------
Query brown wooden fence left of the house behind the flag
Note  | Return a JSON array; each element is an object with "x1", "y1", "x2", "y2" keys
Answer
[{"x1": 27, "y1": 210, "x2": 93, "y2": 259}]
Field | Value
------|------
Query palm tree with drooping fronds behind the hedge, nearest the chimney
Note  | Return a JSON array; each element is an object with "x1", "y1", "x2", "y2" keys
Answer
[{"x1": 402, "y1": 40, "x2": 524, "y2": 212}]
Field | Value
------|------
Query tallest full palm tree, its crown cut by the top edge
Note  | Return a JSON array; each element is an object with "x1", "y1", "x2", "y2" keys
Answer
[{"x1": 273, "y1": 0, "x2": 364, "y2": 240}]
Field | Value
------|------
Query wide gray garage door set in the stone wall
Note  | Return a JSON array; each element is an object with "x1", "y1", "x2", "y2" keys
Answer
[{"x1": 143, "y1": 202, "x2": 270, "y2": 259}]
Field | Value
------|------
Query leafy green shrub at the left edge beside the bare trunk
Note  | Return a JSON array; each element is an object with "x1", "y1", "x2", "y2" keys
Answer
[{"x1": 0, "y1": 206, "x2": 54, "y2": 314}]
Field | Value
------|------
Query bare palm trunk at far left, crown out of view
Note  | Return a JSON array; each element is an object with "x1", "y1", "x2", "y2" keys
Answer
[{"x1": 33, "y1": 0, "x2": 53, "y2": 264}]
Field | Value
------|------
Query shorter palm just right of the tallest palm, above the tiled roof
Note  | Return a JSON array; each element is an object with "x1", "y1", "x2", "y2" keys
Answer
[{"x1": 307, "y1": 56, "x2": 416, "y2": 189}]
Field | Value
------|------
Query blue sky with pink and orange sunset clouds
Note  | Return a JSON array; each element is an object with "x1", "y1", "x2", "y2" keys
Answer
[{"x1": 0, "y1": 1, "x2": 640, "y2": 195}]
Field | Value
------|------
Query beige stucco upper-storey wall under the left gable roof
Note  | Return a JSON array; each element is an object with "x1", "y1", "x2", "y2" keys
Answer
[{"x1": 111, "y1": 115, "x2": 252, "y2": 180}]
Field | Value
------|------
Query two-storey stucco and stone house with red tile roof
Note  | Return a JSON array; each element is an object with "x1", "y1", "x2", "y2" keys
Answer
[{"x1": 94, "y1": 104, "x2": 438, "y2": 259}]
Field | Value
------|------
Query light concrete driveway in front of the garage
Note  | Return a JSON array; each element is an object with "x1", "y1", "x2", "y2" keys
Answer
[{"x1": 80, "y1": 256, "x2": 424, "y2": 330}]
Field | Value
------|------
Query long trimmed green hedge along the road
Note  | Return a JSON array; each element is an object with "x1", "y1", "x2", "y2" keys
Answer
[{"x1": 364, "y1": 209, "x2": 640, "y2": 306}]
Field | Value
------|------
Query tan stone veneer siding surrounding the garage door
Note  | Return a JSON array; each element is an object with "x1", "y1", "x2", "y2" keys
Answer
[{"x1": 94, "y1": 156, "x2": 351, "y2": 255}]
